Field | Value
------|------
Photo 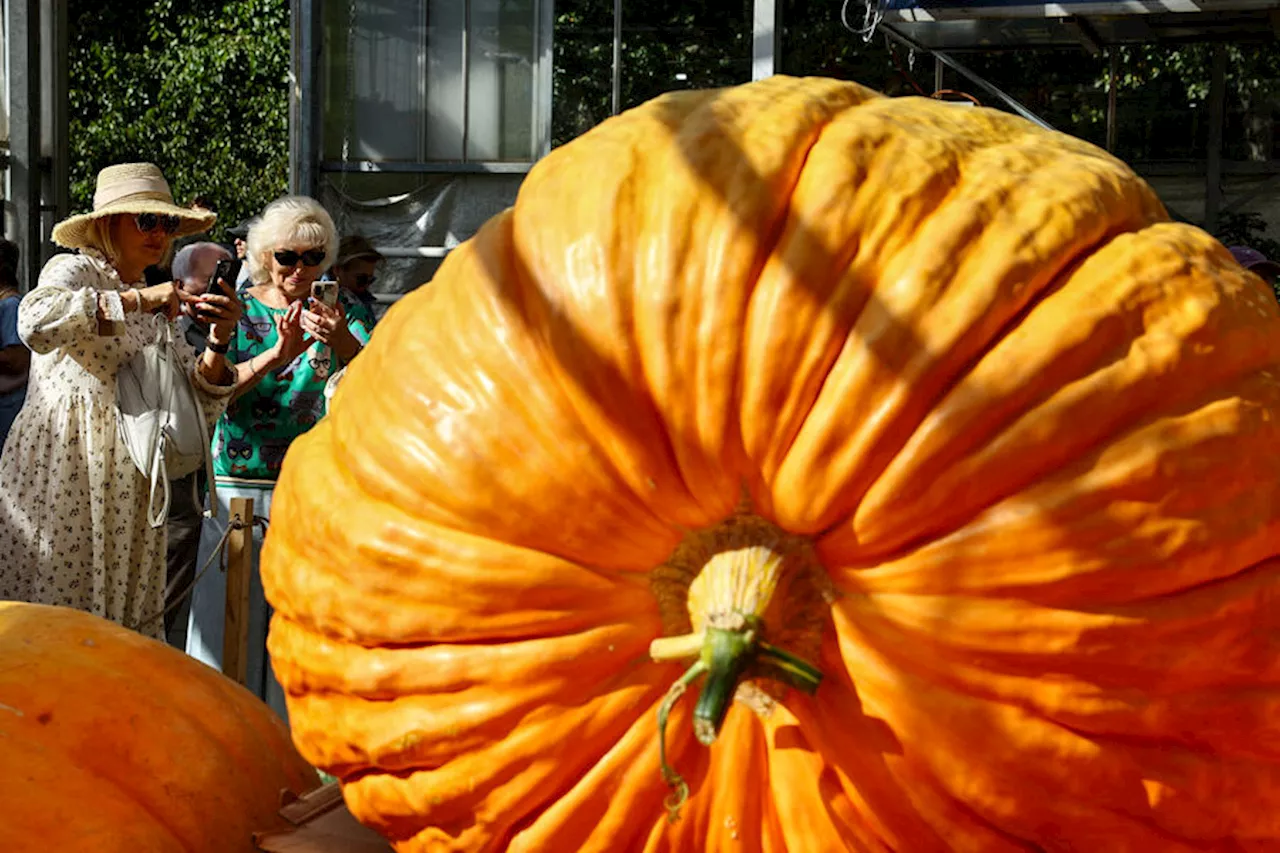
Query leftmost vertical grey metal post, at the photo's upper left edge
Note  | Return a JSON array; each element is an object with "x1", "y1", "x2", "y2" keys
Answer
[{"x1": 5, "y1": 0, "x2": 45, "y2": 289}]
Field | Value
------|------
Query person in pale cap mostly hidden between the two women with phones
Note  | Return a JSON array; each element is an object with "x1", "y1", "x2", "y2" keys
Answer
[{"x1": 164, "y1": 235, "x2": 234, "y2": 648}]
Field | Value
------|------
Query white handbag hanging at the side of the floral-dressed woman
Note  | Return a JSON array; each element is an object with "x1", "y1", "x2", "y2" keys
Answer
[{"x1": 115, "y1": 315, "x2": 218, "y2": 528}]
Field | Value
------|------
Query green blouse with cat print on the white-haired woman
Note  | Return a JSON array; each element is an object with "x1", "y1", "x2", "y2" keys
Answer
[{"x1": 214, "y1": 291, "x2": 374, "y2": 480}]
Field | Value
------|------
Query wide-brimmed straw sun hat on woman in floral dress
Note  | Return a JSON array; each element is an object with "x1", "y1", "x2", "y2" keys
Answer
[{"x1": 54, "y1": 163, "x2": 218, "y2": 248}]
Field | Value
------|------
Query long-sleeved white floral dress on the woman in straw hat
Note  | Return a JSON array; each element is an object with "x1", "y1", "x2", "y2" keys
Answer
[{"x1": 0, "y1": 251, "x2": 230, "y2": 638}]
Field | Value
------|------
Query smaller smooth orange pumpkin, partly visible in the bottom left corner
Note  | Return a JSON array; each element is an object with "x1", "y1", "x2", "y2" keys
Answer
[{"x1": 0, "y1": 602, "x2": 320, "y2": 853}]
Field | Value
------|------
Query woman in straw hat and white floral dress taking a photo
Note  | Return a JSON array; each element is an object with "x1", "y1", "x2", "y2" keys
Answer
[{"x1": 0, "y1": 163, "x2": 241, "y2": 637}]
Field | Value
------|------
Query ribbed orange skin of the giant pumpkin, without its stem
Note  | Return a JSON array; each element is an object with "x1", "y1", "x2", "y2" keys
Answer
[{"x1": 262, "y1": 77, "x2": 1280, "y2": 853}]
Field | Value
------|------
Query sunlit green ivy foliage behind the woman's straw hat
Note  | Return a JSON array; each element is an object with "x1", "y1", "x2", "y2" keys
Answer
[{"x1": 68, "y1": 0, "x2": 289, "y2": 238}]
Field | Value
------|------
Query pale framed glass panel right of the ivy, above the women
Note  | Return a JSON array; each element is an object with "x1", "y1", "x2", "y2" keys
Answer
[{"x1": 321, "y1": 0, "x2": 550, "y2": 163}]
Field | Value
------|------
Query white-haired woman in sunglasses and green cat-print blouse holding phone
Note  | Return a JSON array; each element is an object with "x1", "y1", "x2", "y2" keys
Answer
[{"x1": 187, "y1": 196, "x2": 374, "y2": 713}]
